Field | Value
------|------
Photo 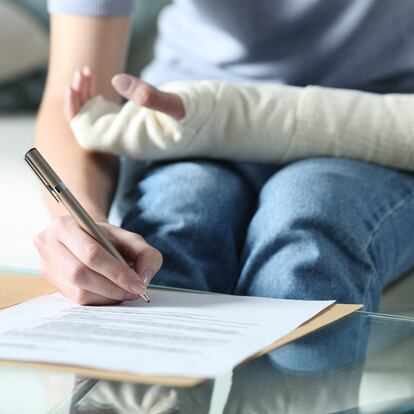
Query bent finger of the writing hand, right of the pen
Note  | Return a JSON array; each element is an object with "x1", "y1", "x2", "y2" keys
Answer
[{"x1": 102, "y1": 226, "x2": 163, "y2": 286}]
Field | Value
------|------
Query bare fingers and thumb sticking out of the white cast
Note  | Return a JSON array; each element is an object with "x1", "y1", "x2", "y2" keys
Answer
[{"x1": 64, "y1": 66, "x2": 185, "y2": 123}]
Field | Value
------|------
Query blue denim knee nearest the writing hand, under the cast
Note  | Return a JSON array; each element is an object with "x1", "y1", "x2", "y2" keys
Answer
[{"x1": 122, "y1": 160, "x2": 256, "y2": 292}]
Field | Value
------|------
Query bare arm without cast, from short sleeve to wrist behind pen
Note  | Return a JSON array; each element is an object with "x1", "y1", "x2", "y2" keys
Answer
[{"x1": 36, "y1": 14, "x2": 130, "y2": 220}]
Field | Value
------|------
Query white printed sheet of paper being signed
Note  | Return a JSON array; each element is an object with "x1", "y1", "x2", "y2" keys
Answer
[{"x1": 0, "y1": 289, "x2": 333, "y2": 378}]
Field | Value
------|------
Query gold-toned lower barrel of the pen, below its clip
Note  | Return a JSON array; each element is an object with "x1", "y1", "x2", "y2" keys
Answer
[{"x1": 58, "y1": 188, "x2": 127, "y2": 264}]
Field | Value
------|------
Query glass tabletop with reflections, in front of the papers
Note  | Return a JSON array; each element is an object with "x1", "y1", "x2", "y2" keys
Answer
[{"x1": 0, "y1": 292, "x2": 414, "y2": 414}]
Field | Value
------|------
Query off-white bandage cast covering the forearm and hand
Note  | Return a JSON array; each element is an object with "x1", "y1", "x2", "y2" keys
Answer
[{"x1": 71, "y1": 81, "x2": 414, "y2": 170}]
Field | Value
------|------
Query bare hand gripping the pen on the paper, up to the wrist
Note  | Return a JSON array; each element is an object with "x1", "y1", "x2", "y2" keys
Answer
[{"x1": 34, "y1": 216, "x2": 162, "y2": 305}]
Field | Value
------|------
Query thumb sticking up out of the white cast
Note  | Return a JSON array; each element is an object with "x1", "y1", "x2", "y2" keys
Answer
[{"x1": 112, "y1": 73, "x2": 185, "y2": 121}]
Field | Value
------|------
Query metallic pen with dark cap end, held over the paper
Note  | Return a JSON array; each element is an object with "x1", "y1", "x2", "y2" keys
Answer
[{"x1": 24, "y1": 148, "x2": 150, "y2": 303}]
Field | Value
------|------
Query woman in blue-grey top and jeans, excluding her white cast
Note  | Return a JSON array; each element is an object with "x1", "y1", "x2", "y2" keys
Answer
[{"x1": 36, "y1": 0, "x2": 414, "y2": 310}]
